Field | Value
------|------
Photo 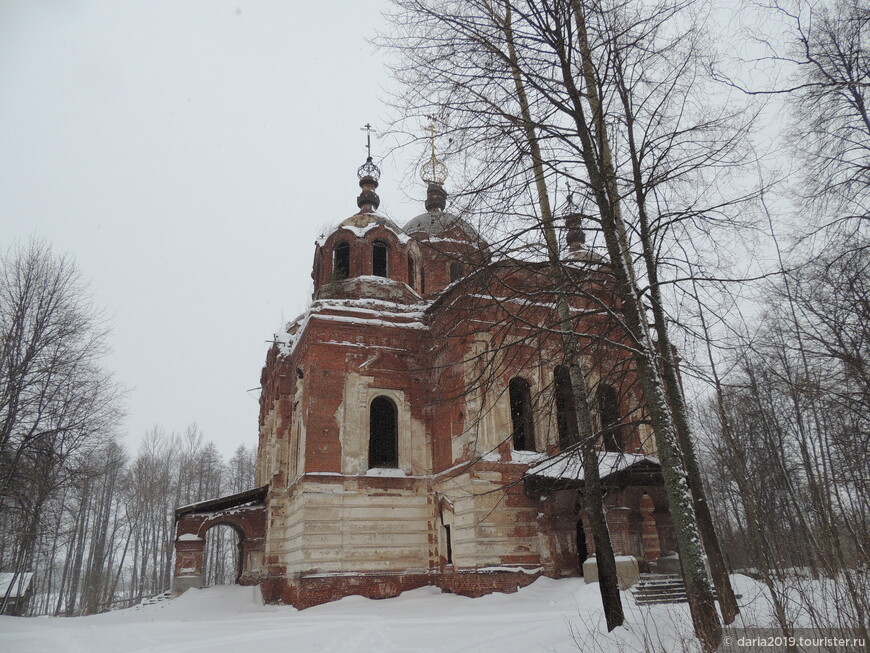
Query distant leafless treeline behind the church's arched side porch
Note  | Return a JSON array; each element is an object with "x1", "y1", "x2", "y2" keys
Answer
[{"x1": 0, "y1": 425, "x2": 256, "y2": 615}]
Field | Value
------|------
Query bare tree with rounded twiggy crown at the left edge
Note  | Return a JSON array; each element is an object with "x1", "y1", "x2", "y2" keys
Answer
[{"x1": 0, "y1": 241, "x2": 120, "y2": 612}]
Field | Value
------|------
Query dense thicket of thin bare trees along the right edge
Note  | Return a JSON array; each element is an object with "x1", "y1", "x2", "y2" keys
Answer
[{"x1": 706, "y1": 233, "x2": 870, "y2": 632}]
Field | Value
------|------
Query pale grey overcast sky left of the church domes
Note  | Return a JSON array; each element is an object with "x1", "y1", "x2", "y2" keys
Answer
[{"x1": 0, "y1": 0, "x2": 425, "y2": 455}]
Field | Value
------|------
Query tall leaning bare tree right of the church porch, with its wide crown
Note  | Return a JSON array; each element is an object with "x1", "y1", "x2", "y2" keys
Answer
[{"x1": 384, "y1": 0, "x2": 764, "y2": 648}]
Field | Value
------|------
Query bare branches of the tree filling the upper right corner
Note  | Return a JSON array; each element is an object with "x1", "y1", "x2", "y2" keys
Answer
[{"x1": 711, "y1": 0, "x2": 870, "y2": 238}]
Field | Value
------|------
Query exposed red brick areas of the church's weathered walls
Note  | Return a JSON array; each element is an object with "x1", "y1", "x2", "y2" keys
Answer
[{"x1": 247, "y1": 226, "x2": 676, "y2": 607}]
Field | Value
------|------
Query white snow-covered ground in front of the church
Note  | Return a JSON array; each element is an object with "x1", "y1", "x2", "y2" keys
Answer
[{"x1": 0, "y1": 576, "x2": 784, "y2": 653}]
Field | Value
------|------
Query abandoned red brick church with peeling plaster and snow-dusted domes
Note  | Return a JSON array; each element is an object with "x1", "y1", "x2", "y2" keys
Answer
[{"x1": 173, "y1": 146, "x2": 674, "y2": 608}]
